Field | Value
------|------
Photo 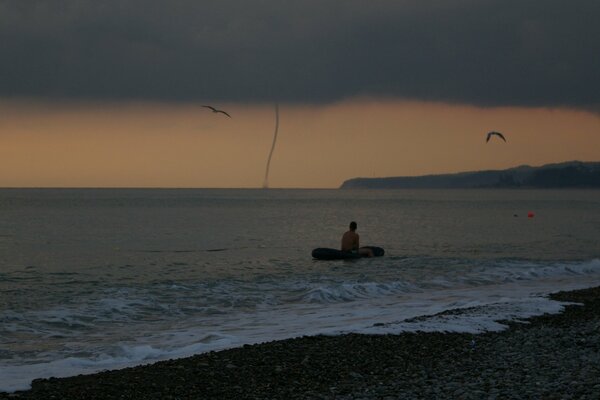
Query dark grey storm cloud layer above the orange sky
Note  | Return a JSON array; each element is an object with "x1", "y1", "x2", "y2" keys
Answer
[{"x1": 0, "y1": 0, "x2": 600, "y2": 108}]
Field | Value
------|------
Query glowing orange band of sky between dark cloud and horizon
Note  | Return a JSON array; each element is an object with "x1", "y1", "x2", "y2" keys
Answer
[{"x1": 0, "y1": 99, "x2": 600, "y2": 188}]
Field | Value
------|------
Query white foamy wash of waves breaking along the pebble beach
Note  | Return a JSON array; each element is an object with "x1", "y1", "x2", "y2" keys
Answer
[{"x1": 0, "y1": 276, "x2": 600, "y2": 392}]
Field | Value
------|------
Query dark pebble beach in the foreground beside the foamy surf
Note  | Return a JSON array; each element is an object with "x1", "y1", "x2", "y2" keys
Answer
[{"x1": 0, "y1": 287, "x2": 600, "y2": 400}]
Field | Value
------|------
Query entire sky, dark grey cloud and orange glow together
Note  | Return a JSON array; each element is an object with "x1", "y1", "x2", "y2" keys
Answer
[{"x1": 0, "y1": 0, "x2": 600, "y2": 187}]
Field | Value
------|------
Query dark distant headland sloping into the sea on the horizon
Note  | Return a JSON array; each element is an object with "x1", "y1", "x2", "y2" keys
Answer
[{"x1": 340, "y1": 161, "x2": 600, "y2": 189}]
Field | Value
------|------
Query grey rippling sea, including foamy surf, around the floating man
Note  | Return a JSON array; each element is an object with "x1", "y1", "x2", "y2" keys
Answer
[{"x1": 0, "y1": 189, "x2": 600, "y2": 391}]
